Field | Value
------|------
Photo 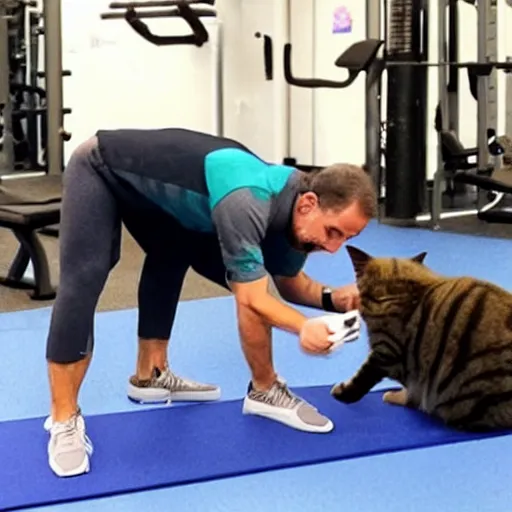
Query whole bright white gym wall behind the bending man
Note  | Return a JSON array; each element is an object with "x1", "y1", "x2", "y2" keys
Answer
[{"x1": 50, "y1": 0, "x2": 512, "y2": 177}]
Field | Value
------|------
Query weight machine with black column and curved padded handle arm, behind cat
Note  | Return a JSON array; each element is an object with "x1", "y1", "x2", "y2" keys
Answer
[{"x1": 274, "y1": 0, "x2": 512, "y2": 229}]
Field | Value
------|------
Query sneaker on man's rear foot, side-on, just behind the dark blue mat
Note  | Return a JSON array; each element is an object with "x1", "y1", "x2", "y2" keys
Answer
[{"x1": 128, "y1": 368, "x2": 220, "y2": 404}]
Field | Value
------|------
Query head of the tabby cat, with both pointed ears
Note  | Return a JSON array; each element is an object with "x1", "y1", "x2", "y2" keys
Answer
[{"x1": 347, "y1": 246, "x2": 428, "y2": 320}]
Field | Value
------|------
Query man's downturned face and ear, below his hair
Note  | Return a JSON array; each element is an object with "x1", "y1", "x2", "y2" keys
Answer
[{"x1": 292, "y1": 192, "x2": 369, "y2": 253}]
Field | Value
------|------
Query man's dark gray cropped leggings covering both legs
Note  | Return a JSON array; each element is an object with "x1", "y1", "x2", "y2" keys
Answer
[{"x1": 46, "y1": 137, "x2": 227, "y2": 363}]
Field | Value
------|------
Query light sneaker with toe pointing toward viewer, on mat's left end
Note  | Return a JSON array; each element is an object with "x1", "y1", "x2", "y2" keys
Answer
[{"x1": 45, "y1": 411, "x2": 93, "y2": 477}]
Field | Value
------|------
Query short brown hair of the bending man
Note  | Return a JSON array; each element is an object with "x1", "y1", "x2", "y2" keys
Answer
[{"x1": 300, "y1": 164, "x2": 377, "y2": 219}]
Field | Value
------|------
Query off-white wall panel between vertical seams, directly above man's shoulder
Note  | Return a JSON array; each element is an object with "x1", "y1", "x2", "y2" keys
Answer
[{"x1": 216, "y1": 0, "x2": 287, "y2": 161}]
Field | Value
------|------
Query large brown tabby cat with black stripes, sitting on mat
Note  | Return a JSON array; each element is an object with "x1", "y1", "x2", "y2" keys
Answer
[{"x1": 331, "y1": 247, "x2": 512, "y2": 431}]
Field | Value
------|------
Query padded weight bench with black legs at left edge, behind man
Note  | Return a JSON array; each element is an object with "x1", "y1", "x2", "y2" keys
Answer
[{"x1": 0, "y1": 175, "x2": 62, "y2": 300}]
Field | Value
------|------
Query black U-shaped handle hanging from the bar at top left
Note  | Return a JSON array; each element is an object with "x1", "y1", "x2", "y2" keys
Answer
[{"x1": 124, "y1": 3, "x2": 208, "y2": 46}]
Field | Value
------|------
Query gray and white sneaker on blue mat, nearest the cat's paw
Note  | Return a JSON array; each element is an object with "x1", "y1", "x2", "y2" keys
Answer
[{"x1": 243, "y1": 380, "x2": 334, "y2": 433}]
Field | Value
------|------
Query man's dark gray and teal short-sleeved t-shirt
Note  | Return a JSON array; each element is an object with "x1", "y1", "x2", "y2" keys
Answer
[{"x1": 97, "y1": 128, "x2": 306, "y2": 282}]
